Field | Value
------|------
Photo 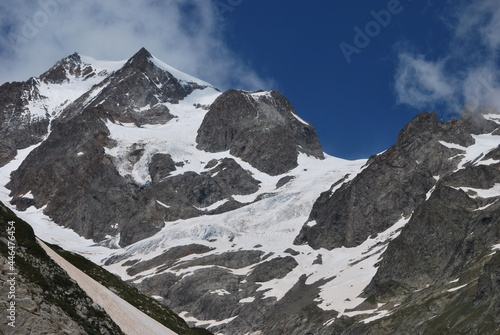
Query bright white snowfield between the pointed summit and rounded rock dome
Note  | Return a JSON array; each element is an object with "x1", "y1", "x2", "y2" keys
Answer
[{"x1": 105, "y1": 88, "x2": 221, "y2": 186}]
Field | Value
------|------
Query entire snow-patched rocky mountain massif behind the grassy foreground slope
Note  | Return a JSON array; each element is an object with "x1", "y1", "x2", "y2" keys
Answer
[{"x1": 0, "y1": 49, "x2": 500, "y2": 335}]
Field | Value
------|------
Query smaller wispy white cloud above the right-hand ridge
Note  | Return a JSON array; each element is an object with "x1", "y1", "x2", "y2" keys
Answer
[{"x1": 394, "y1": 0, "x2": 500, "y2": 115}]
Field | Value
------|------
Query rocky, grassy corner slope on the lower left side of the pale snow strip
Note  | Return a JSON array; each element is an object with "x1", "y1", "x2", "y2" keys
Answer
[{"x1": 0, "y1": 203, "x2": 122, "y2": 334}]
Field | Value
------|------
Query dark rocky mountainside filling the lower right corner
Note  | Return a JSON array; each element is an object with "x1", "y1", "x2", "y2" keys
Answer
[{"x1": 332, "y1": 118, "x2": 500, "y2": 334}]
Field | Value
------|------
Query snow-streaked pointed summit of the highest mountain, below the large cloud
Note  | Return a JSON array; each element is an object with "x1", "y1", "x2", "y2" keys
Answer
[{"x1": 18, "y1": 48, "x2": 214, "y2": 128}]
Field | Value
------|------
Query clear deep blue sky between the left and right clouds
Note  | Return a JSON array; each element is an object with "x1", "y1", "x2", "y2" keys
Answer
[{"x1": 220, "y1": 0, "x2": 500, "y2": 159}]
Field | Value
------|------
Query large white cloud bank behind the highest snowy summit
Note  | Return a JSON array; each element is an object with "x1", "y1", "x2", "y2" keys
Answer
[{"x1": 0, "y1": 0, "x2": 274, "y2": 89}]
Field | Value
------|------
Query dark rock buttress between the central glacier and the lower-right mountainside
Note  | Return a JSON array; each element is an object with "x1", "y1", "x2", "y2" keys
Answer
[{"x1": 295, "y1": 156, "x2": 434, "y2": 249}]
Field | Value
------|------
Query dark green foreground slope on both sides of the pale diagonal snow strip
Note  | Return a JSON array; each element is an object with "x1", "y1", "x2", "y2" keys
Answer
[{"x1": 0, "y1": 203, "x2": 211, "y2": 335}]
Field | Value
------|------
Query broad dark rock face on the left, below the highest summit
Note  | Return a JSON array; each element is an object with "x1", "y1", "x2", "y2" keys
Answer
[{"x1": 8, "y1": 111, "x2": 163, "y2": 247}]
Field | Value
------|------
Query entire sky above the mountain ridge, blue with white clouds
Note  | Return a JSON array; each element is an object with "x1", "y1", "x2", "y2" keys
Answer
[{"x1": 0, "y1": 0, "x2": 500, "y2": 159}]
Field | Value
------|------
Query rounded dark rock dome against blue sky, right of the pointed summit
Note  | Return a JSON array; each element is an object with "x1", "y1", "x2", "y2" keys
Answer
[{"x1": 196, "y1": 90, "x2": 323, "y2": 175}]
